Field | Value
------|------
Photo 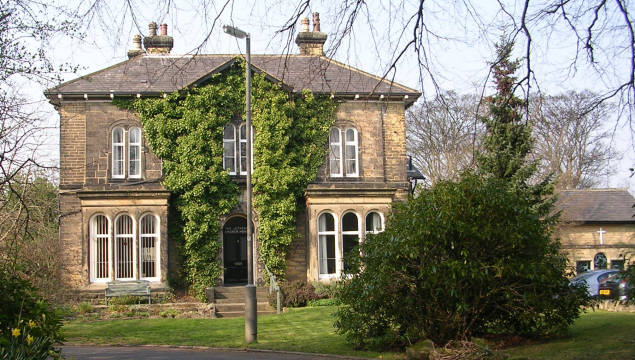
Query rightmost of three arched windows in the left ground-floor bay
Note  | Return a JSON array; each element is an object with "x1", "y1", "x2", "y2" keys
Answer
[{"x1": 139, "y1": 214, "x2": 159, "y2": 279}]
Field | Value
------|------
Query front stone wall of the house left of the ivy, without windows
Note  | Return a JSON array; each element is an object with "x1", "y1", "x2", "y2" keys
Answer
[{"x1": 58, "y1": 101, "x2": 168, "y2": 289}]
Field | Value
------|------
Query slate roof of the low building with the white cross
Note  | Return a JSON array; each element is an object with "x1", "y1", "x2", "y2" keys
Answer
[{"x1": 556, "y1": 189, "x2": 635, "y2": 223}]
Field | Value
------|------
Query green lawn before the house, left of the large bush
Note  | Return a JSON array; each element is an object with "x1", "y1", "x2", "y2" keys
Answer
[{"x1": 63, "y1": 306, "x2": 381, "y2": 357}]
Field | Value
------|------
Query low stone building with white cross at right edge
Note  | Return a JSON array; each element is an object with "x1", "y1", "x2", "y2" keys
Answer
[{"x1": 556, "y1": 189, "x2": 635, "y2": 273}]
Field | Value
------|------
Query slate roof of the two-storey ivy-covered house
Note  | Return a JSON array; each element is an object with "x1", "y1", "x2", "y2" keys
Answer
[{"x1": 45, "y1": 55, "x2": 420, "y2": 103}]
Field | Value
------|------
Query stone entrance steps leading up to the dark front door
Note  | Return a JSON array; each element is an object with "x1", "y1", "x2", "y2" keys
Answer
[{"x1": 213, "y1": 286, "x2": 276, "y2": 317}]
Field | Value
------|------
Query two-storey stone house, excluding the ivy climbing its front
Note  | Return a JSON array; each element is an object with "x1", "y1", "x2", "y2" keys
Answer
[{"x1": 45, "y1": 16, "x2": 420, "y2": 291}]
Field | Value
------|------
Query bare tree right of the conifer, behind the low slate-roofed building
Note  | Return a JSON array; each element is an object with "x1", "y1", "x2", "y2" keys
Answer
[{"x1": 530, "y1": 91, "x2": 618, "y2": 189}]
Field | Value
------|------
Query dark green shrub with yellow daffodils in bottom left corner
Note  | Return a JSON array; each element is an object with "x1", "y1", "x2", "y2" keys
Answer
[{"x1": 0, "y1": 267, "x2": 63, "y2": 359}]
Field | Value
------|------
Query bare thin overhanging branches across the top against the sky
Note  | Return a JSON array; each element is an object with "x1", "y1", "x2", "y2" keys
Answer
[{"x1": 67, "y1": 0, "x2": 635, "y2": 148}]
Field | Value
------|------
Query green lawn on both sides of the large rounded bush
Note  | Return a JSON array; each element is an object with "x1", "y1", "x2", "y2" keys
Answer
[{"x1": 63, "y1": 306, "x2": 635, "y2": 360}]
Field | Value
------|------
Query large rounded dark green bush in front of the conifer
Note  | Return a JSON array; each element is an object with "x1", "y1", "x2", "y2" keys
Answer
[{"x1": 335, "y1": 173, "x2": 588, "y2": 347}]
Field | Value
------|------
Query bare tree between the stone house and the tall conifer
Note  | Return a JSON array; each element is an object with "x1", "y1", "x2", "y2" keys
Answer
[{"x1": 406, "y1": 92, "x2": 484, "y2": 183}]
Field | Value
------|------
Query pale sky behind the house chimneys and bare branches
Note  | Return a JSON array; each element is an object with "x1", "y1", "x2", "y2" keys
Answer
[{"x1": 33, "y1": 0, "x2": 635, "y2": 194}]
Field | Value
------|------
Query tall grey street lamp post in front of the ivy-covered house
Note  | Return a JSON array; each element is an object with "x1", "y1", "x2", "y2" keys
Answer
[{"x1": 223, "y1": 25, "x2": 258, "y2": 344}]
